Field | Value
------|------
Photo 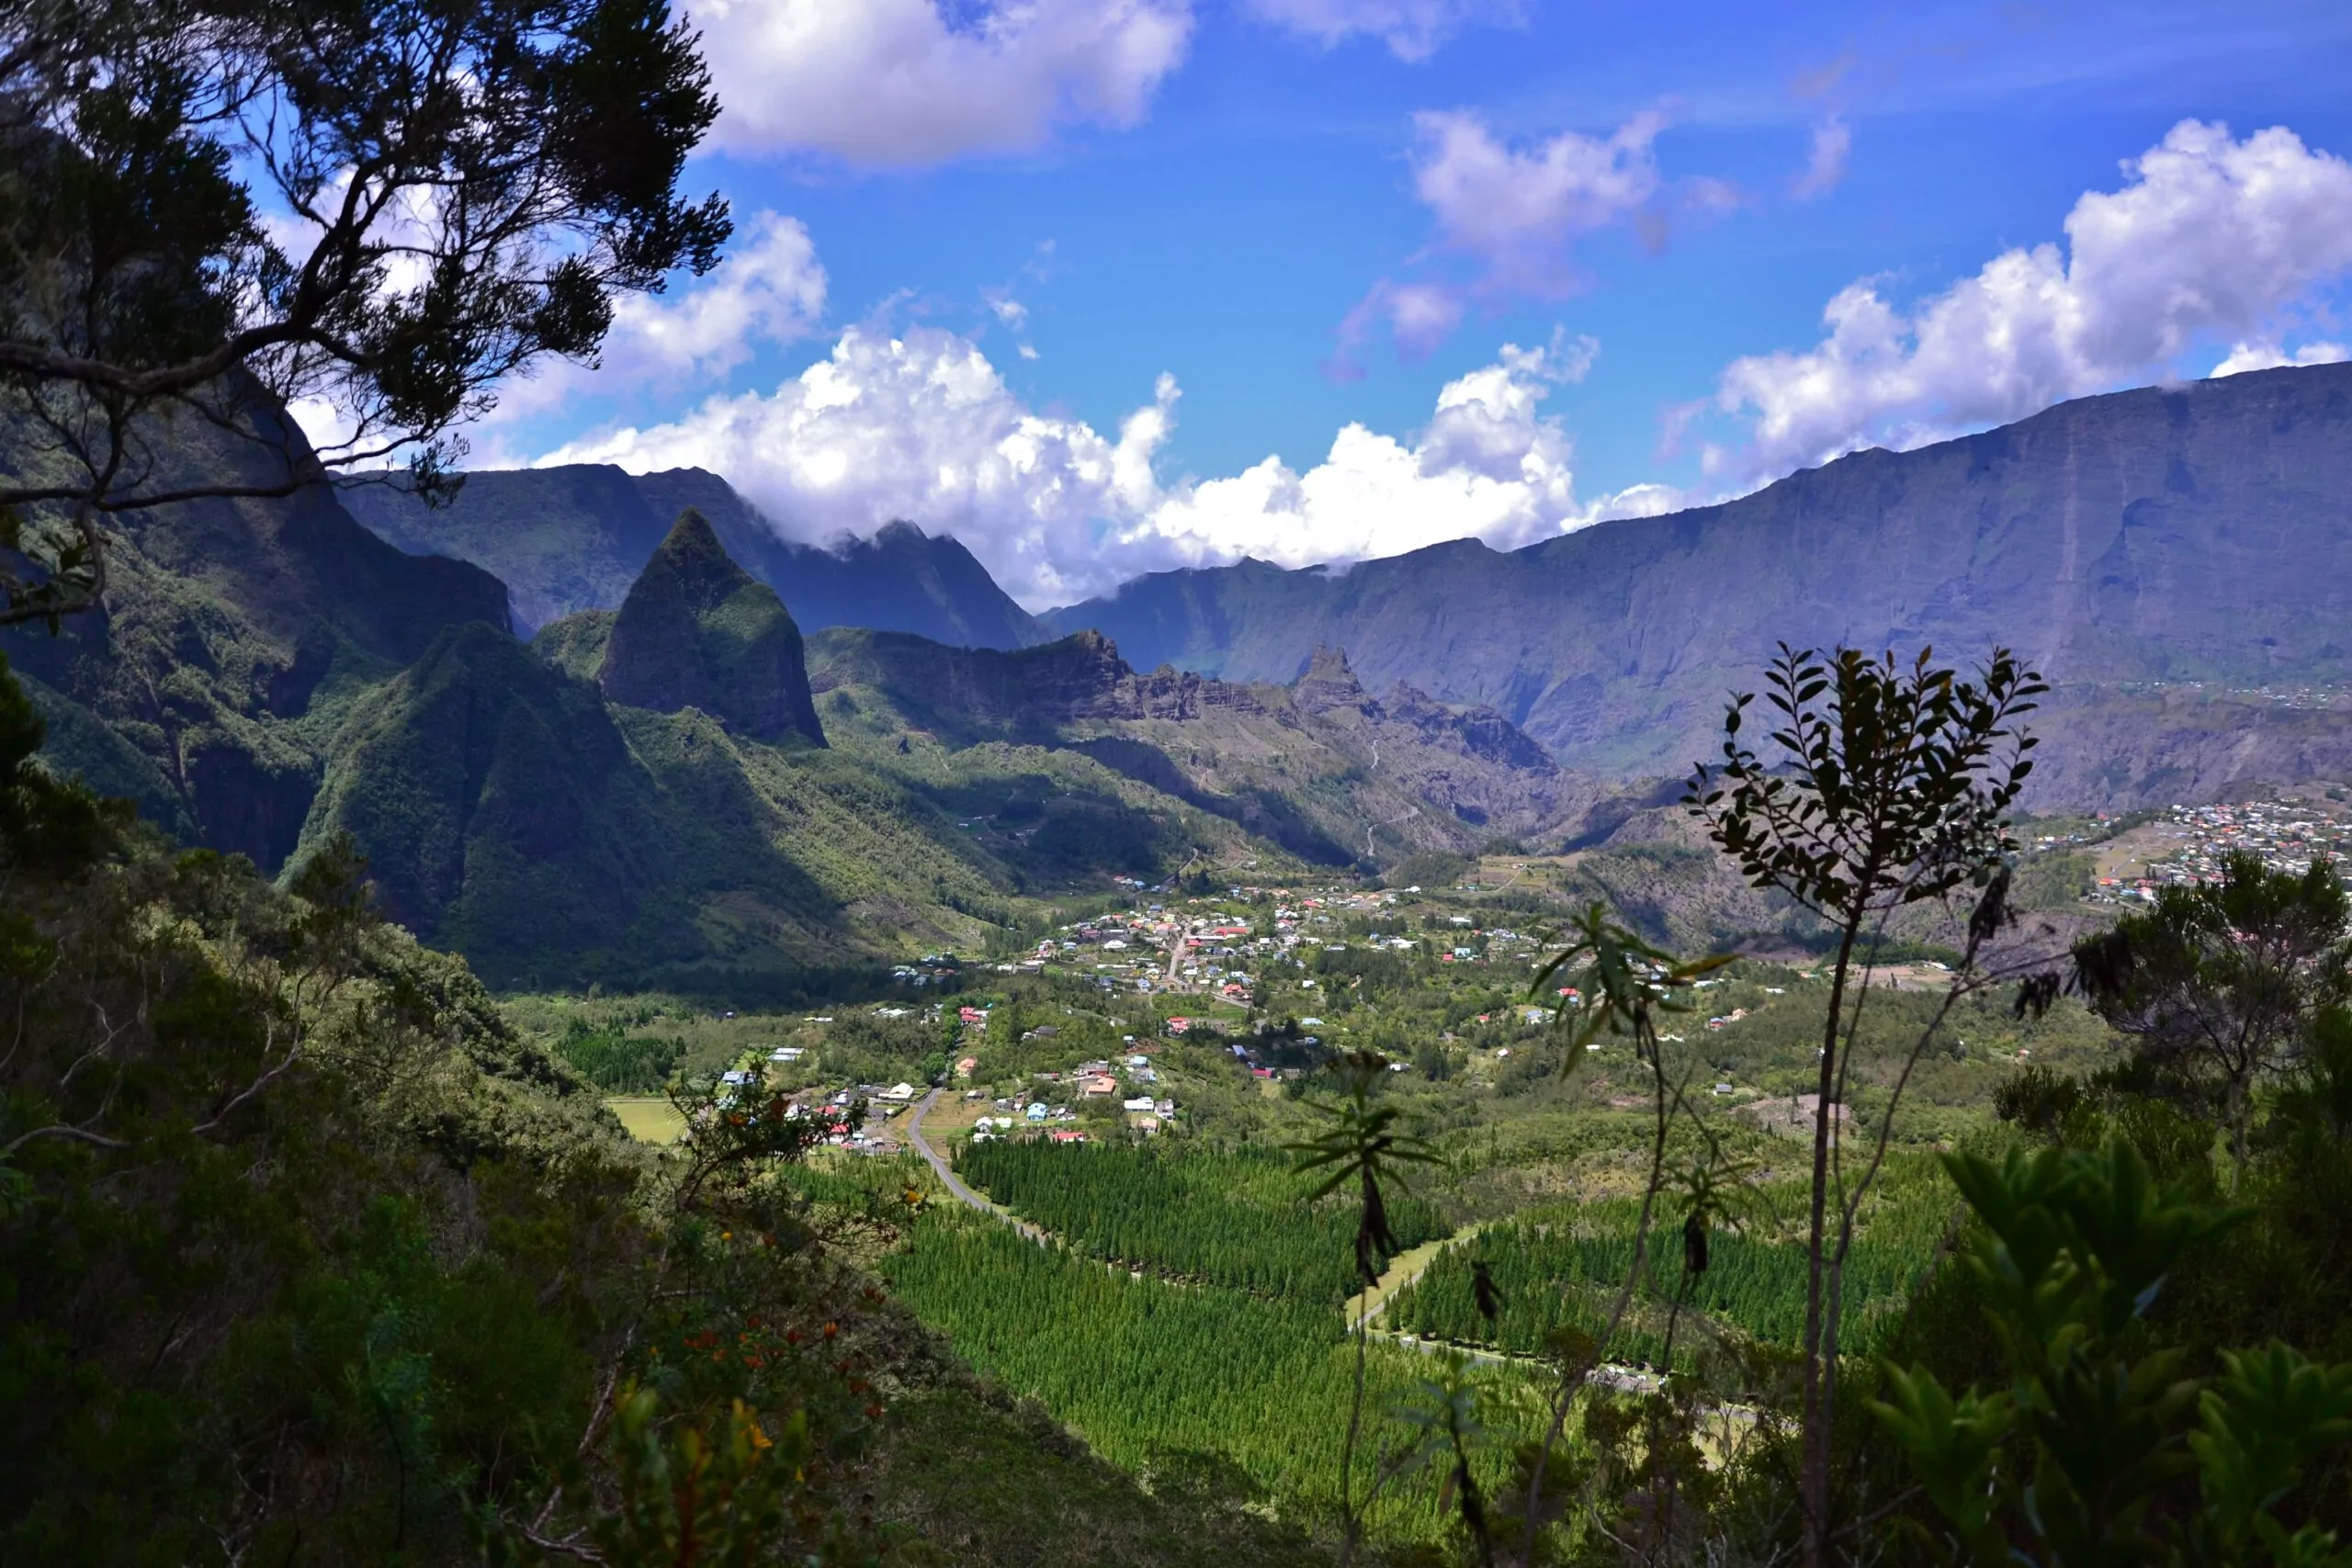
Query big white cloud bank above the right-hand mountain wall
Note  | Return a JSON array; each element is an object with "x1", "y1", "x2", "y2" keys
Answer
[{"x1": 1705, "y1": 120, "x2": 2352, "y2": 479}]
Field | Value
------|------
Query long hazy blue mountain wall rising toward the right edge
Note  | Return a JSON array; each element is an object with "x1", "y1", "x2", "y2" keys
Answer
[{"x1": 1046, "y1": 365, "x2": 2352, "y2": 807}]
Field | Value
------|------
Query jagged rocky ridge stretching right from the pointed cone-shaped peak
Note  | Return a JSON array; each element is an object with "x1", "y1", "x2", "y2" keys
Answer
[{"x1": 809, "y1": 630, "x2": 1597, "y2": 865}]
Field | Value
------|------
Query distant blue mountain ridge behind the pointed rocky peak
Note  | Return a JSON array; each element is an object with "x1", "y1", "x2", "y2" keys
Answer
[{"x1": 345, "y1": 463, "x2": 1051, "y2": 649}]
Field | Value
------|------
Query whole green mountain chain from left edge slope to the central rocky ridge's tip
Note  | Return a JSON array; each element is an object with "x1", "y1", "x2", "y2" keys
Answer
[{"x1": 7, "y1": 404, "x2": 1618, "y2": 997}]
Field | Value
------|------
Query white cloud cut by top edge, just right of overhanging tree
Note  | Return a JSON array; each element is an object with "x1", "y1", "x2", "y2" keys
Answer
[{"x1": 692, "y1": 0, "x2": 1193, "y2": 164}]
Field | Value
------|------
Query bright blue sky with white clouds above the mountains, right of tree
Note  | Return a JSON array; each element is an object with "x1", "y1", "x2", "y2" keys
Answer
[{"x1": 433, "y1": 0, "x2": 2352, "y2": 606}]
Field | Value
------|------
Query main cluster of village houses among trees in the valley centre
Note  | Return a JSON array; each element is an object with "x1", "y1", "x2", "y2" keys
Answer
[{"x1": 673, "y1": 882, "x2": 1574, "y2": 1155}]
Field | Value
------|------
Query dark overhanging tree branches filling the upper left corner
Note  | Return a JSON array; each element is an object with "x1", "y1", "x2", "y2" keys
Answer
[{"x1": 0, "y1": 0, "x2": 729, "y2": 626}]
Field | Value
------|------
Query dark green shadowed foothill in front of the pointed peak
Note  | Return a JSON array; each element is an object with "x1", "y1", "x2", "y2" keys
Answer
[{"x1": 306, "y1": 626, "x2": 1016, "y2": 995}]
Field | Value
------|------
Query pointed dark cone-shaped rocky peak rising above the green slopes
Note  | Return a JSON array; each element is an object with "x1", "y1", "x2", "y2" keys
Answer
[{"x1": 597, "y1": 508, "x2": 826, "y2": 745}]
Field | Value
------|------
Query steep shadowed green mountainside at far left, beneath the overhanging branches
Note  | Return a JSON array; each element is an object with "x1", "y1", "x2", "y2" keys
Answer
[{"x1": 0, "y1": 409, "x2": 508, "y2": 872}]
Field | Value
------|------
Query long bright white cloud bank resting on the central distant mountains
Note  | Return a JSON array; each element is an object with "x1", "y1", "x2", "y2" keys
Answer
[{"x1": 538, "y1": 327, "x2": 1646, "y2": 609}]
